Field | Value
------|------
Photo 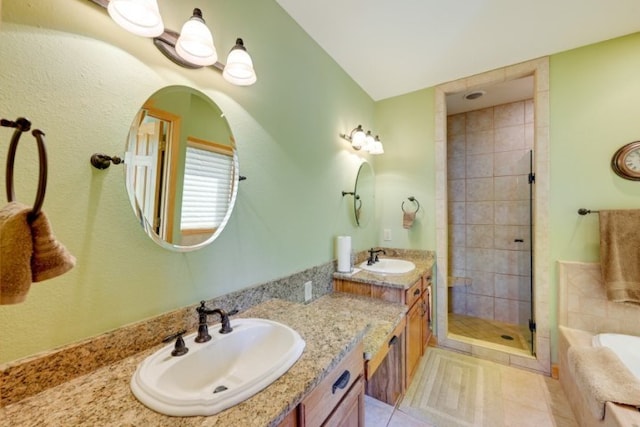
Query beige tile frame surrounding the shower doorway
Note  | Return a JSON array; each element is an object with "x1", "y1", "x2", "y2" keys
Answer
[{"x1": 435, "y1": 57, "x2": 551, "y2": 374}]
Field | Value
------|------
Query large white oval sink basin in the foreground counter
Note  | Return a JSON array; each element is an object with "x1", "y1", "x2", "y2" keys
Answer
[{"x1": 131, "y1": 319, "x2": 305, "y2": 416}]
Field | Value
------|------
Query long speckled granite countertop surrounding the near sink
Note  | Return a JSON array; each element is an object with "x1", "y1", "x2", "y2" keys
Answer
[{"x1": 0, "y1": 293, "x2": 406, "y2": 427}]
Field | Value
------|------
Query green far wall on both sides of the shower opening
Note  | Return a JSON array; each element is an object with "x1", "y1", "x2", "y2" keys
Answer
[{"x1": 376, "y1": 33, "x2": 640, "y2": 360}]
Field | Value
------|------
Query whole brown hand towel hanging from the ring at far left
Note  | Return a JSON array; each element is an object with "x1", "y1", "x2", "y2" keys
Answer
[{"x1": 0, "y1": 202, "x2": 76, "y2": 305}]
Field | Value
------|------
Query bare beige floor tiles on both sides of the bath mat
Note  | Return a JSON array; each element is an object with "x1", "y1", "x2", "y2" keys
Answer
[{"x1": 365, "y1": 350, "x2": 578, "y2": 427}]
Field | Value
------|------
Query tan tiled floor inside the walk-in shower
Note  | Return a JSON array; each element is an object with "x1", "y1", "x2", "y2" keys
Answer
[{"x1": 449, "y1": 313, "x2": 531, "y2": 352}]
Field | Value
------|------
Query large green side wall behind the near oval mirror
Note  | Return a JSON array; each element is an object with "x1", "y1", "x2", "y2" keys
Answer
[{"x1": 0, "y1": 0, "x2": 377, "y2": 363}]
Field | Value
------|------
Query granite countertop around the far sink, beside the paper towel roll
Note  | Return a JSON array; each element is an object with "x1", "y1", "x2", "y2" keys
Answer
[{"x1": 333, "y1": 249, "x2": 434, "y2": 289}]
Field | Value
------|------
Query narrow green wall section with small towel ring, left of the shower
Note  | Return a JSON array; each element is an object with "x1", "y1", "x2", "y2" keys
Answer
[{"x1": 375, "y1": 89, "x2": 436, "y2": 250}]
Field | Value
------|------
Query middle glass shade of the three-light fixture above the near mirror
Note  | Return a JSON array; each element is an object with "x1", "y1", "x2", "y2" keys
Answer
[{"x1": 176, "y1": 9, "x2": 218, "y2": 67}]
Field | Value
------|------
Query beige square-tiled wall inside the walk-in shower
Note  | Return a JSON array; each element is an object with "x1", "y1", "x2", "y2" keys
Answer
[{"x1": 447, "y1": 100, "x2": 534, "y2": 324}]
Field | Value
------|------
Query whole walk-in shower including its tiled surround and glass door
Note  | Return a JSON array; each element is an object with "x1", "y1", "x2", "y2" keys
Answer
[{"x1": 434, "y1": 58, "x2": 551, "y2": 375}]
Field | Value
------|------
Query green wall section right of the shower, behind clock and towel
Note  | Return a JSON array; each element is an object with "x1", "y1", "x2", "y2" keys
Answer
[{"x1": 548, "y1": 33, "x2": 640, "y2": 352}]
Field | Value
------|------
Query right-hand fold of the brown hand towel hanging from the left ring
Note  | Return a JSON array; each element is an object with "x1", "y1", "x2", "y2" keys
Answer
[{"x1": 31, "y1": 211, "x2": 76, "y2": 282}]
